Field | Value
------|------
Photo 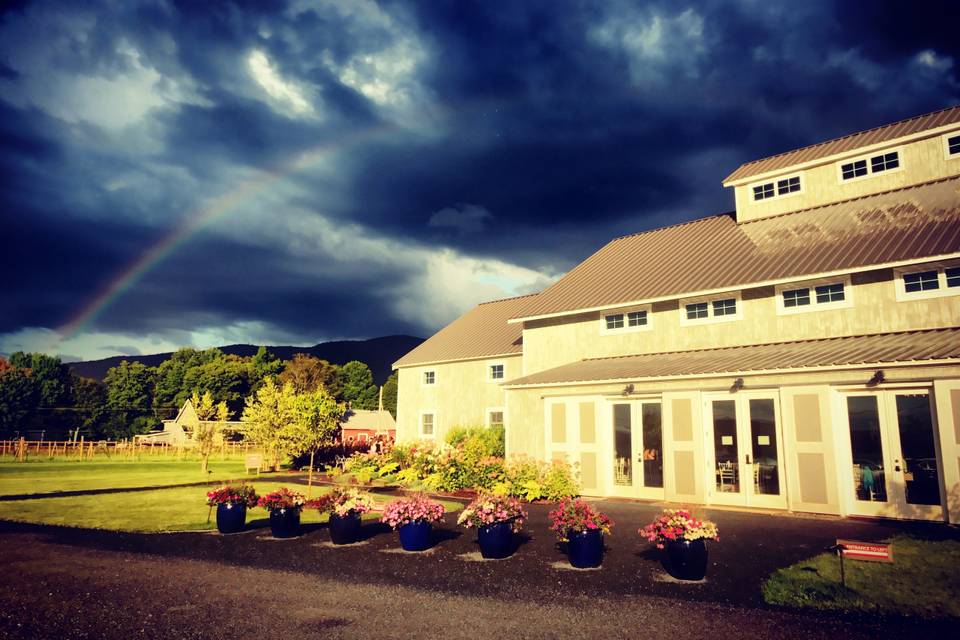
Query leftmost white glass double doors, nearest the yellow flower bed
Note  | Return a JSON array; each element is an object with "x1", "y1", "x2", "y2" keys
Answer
[{"x1": 609, "y1": 400, "x2": 663, "y2": 499}]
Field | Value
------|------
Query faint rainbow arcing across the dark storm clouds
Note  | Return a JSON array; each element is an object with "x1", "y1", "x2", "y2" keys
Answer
[{"x1": 51, "y1": 125, "x2": 396, "y2": 349}]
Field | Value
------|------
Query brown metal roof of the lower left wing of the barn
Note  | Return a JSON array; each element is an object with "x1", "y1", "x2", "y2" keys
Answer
[{"x1": 393, "y1": 294, "x2": 536, "y2": 368}]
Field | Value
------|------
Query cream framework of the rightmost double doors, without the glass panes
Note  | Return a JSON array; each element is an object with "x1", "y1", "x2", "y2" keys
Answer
[{"x1": 838, "y1": 385, "x2": 946, "y2": 521}]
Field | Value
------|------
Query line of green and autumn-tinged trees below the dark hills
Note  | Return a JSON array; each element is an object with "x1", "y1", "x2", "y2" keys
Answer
[{"x1": 0, "y1": 347, "x2": 397, "y2": 440}]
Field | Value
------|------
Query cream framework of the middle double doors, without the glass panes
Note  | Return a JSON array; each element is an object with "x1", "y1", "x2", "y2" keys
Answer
[{"x1": 703, "y1": 389, "x2": 788, "y2": 510}]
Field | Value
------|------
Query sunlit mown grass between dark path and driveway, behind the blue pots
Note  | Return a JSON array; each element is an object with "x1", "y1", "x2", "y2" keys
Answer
[{"x1": 0, "y1": 481, "x2": 462, "y2": 533}]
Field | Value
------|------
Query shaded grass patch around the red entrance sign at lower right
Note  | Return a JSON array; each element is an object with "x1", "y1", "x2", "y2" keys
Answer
[{"x1": 763, "y1": 536, "x2": 960, "y2": 618}]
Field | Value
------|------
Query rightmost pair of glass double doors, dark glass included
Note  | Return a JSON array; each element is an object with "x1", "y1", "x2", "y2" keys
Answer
[{"x1": 845, "y1": 390, "x2": 943, "y2": 520}]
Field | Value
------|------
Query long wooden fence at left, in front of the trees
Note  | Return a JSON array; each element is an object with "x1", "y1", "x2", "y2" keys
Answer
[{"x1": 0, "y1": 437, "x2": 259, "y2": 462}]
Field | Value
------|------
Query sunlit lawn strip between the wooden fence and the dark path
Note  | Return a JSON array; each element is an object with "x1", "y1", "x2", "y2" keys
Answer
[{"x1": 0, "y1": 458, "x2": 252, "y2": 496}]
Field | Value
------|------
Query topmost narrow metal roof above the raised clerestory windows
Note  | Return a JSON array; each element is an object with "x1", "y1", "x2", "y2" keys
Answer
[{"x1": 723, "y1": 106, "x2": 960, "y2": 184}]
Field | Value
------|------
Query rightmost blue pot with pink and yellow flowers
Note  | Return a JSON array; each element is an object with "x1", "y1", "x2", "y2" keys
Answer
[{"x1": 638, "y1": 509, "x2": 720, "y2": 580}]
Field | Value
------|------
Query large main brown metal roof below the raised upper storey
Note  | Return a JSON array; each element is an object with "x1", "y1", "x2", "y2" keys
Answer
[{"x1": 512, "y1": 176, "x2": 960, "y2": 319}]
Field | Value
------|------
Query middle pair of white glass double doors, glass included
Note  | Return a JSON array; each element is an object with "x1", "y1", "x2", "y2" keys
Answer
[{"x1": 704, "y1": 392, "x2": 787, "y2": 509}]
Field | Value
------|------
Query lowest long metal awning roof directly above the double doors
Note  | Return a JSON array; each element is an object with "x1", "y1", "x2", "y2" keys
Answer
[{"x1": 506, "y1": 327, "x2": 960, "y2": 387}]
